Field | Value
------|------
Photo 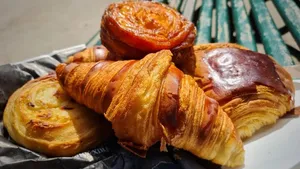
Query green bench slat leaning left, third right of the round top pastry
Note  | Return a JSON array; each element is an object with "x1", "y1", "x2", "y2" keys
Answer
[{"x1": 231, "y1": 0, "x2": 257, "y2": 51}]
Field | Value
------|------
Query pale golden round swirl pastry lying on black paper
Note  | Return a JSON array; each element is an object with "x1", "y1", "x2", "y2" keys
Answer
[{"x1": 3, "y1": 75, "x2": 112, "y2": 156}]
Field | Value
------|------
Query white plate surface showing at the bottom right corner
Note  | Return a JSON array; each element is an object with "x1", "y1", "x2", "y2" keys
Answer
[{"x1": 223, "y1": 80, "x2": 300, "y2": 169}]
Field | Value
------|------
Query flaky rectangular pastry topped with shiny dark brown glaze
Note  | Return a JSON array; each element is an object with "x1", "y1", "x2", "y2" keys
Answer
[{"x1": 182, "y1": 43, "x2": 295, "y2": 138}]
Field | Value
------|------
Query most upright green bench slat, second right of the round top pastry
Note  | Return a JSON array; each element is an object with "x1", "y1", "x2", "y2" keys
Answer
[{"x1": 216, "y1": 0, "x2": 230, "y2": 42}]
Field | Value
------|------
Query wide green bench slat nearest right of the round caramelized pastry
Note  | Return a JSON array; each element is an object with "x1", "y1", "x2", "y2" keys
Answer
[{"x1": 196, "y1": 0, "x2": 214, "y2": 44}]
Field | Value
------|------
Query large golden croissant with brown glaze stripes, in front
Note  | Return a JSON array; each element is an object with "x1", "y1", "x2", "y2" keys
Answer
[{"x1": 56, "y1": 50, "x2": 244, "y2": 166}]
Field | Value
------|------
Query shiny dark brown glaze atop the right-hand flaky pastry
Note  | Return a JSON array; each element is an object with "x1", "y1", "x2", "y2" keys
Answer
[{"x1": 203, "y1": 48, "x2": 288, "y2": 98}]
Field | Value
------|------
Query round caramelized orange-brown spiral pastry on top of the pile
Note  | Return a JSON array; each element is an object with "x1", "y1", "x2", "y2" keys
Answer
[{"x1": 100, "y1": 1, "x2": 196, "y2": 60}]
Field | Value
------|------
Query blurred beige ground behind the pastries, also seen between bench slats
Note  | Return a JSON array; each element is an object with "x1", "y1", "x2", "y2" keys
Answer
[{"x1": 0, "y1": 0, "x2": 299, "y2": 65}]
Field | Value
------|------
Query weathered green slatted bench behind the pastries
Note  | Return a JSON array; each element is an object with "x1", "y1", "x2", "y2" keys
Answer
[{"x1": 87, "y1": 0, "x2": 300, "y2": 66}]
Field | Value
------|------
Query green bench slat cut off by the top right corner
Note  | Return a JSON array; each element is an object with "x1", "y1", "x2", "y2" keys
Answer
[{"x1": 273, "y1": 0, "x2": 300, "y2": 46}]
